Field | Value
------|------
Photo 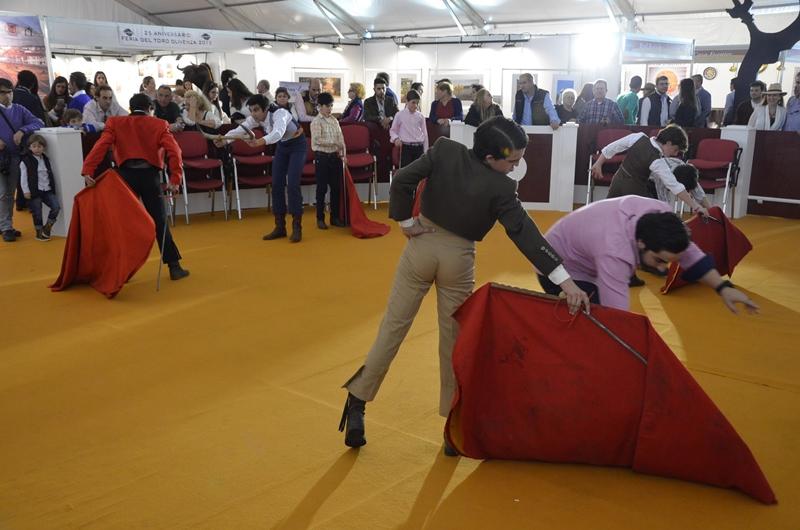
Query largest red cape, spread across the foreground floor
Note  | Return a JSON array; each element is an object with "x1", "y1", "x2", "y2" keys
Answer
[{"x1": 445, "y1": 284, "x2": 776, "y2": 504}]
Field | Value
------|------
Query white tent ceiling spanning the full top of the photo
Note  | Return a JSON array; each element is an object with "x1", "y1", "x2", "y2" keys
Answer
[{"x1": 2, "y1": 0, "x2": 800, "y2": 45}]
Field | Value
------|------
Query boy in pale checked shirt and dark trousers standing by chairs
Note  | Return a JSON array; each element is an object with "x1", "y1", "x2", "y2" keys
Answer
[{"x1": 311, "y1": 92, "x2": 346, "y2": 230}]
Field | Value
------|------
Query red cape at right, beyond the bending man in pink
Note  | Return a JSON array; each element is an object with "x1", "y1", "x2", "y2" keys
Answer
[{"x1": 661, "y1": 206, "x2": 753, "y2": 294}]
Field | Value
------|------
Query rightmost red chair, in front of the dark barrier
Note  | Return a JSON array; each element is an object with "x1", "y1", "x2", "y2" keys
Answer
[{"x1": 689, "y1": 138, "x2": 742, "y2": 217}]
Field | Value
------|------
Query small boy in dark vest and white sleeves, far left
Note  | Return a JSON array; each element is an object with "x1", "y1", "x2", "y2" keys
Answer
[{"x1": 19, "y1": 134, "x2": 61, "y2": 241}]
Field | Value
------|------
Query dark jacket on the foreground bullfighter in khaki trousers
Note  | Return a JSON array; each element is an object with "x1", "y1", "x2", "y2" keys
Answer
[{"x1": 389, "y1": 138, "x2": 561, "y2": 275}]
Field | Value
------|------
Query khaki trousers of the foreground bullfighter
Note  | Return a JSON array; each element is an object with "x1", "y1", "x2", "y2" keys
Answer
[{"x1": 344, "y1": 217, "x2": 475, "y2": 417}]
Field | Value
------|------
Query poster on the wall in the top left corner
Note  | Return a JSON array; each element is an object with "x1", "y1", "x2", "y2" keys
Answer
[{"x1": 0, "y1": 13, "x2": 50, "y2": 96}]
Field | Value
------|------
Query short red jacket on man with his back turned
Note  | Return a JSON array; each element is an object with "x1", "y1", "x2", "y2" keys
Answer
[{"x1": 81, "y1": 114, "x2": 184, "y2": 184}]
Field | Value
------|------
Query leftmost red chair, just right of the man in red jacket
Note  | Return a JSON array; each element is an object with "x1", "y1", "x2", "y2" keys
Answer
[{"x1": 175, "y1": 131, "x2": 228, "y2": 224}]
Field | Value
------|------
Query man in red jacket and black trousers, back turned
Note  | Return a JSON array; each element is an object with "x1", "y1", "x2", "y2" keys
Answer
[{"x1": 81, "y1": 94, "x2": 189, "y2": 280}]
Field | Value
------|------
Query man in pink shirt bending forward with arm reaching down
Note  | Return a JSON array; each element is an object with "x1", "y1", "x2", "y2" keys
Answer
[{"x1": 539, "y1": 195, "x2": 758, "y2": 313}]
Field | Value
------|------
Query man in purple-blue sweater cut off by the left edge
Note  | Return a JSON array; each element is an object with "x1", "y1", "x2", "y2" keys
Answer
[{"x1": 0, "y1": 78, "x2": 44, "y2": 243}]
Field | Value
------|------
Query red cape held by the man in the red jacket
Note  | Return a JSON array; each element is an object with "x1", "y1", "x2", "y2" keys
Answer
[{"x1": 50, "y1": 169, "x2": 156, "y2": 298}]
